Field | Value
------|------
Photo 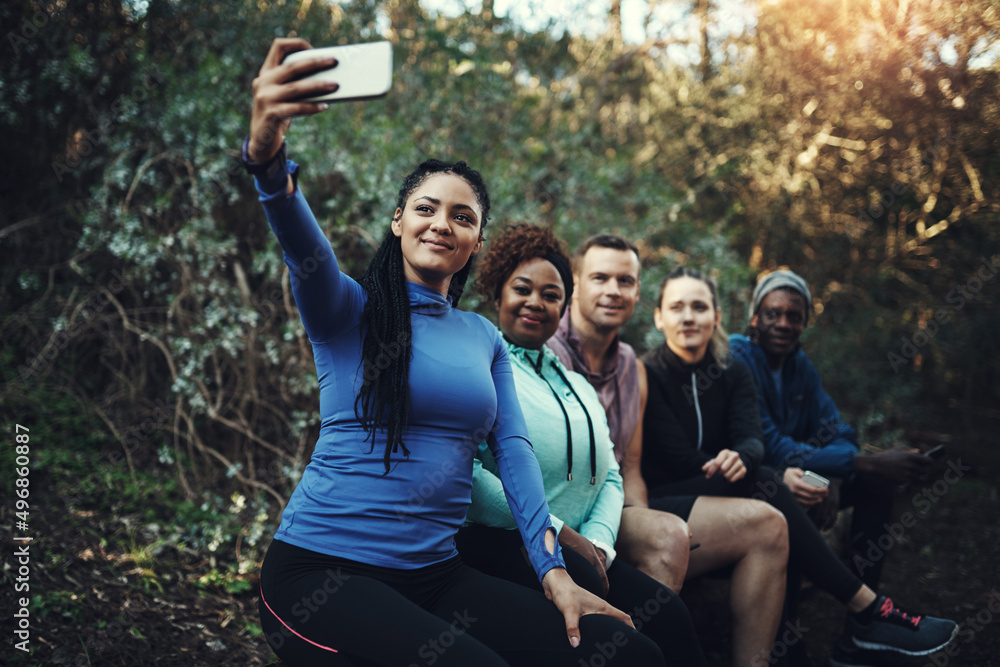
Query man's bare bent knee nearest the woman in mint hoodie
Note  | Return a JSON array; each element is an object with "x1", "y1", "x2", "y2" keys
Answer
[{"x1": 615, "y1": 506, "x2": 691, "y2": 593}]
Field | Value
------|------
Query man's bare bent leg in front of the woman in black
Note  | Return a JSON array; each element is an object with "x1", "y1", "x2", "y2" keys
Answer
[{"x1": 687, "y1": 496, "x2": 788, "y2": 667}]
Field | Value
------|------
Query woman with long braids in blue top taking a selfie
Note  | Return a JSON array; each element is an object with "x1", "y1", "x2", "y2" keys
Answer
[{"x1": 243, "y1": 39, "x2": 660, "y2": 667}]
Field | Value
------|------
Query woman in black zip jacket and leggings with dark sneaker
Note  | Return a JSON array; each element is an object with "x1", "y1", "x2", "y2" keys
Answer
[{"x1": 640, "y1": 267, "x2": 957, "y2": 655}]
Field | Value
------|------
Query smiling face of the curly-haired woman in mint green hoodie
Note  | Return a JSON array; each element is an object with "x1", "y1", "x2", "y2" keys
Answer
[{"x1": 497, "y1": 257, "x2": 566, "y2": 350}]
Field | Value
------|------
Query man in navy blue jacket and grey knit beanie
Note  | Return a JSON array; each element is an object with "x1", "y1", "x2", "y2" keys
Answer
[{"x1": 730, "y1": 271, "x2": 931, "y2": 590}]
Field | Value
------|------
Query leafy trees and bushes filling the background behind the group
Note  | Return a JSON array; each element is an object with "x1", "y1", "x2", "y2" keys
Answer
[{"x1": 0, "y1": 0, "x2": 1000, "y2": 548}]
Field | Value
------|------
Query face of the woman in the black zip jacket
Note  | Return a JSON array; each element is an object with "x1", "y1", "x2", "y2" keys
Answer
[{"x1": 653, "y1": 276, "x2": 722, "y2": 363}]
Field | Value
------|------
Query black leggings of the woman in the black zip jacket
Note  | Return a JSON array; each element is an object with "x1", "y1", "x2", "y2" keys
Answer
[{"x1": 649, "y1": 466, "x2": 862, "y2": 604}]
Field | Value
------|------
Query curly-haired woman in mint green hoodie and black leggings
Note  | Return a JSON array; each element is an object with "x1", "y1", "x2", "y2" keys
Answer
[{"x1": 456, "y1": 224, "x2": 705, "y2": 665}]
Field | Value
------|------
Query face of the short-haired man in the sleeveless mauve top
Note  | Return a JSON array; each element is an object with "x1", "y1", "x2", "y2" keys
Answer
[{"x1": 573, "y1": 246, "x2": 639, "y2": 333}]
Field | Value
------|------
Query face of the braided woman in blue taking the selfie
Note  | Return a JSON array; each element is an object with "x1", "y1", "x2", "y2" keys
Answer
[{"x1": 392, "y1": 173, "x2": 483, "y2": 294}]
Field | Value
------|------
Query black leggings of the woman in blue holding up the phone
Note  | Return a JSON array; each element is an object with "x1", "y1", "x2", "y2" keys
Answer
[{"x1": 260, "y1": 540, "x2": 664, "y2": 667}]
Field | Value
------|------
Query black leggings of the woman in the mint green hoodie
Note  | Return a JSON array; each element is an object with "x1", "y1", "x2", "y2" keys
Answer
[{"x1": 455, "y1": 526, "x2": 705, "y2": 667}]
